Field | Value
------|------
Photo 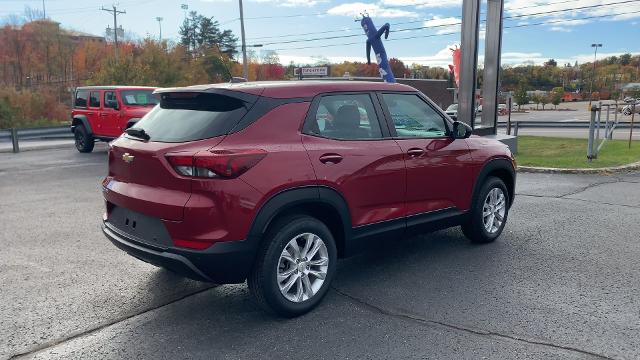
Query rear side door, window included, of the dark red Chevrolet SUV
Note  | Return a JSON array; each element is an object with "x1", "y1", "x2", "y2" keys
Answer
[{"x1": 302, "y1": 92, "x2": 406, "y2": 235}]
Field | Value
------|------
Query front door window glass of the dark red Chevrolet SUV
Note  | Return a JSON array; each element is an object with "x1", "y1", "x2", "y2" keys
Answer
[{"x1": 382, "y1": 94, "x2": 447, "y2": 138}]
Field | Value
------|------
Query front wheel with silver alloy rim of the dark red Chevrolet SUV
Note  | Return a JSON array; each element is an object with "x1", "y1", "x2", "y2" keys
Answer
[{"x1": 462, "y1": 177, "x2": 510, "y2": 244}]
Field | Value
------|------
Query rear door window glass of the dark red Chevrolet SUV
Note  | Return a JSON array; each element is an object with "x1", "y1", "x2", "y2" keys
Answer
[{"x1": 304, "y1": 94, "x2": 382, "y2": 140}]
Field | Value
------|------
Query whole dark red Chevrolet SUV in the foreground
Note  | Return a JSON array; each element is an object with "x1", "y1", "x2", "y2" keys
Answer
[{"x1": 103, "y1": 81, "x2": 515, "y2": 316}]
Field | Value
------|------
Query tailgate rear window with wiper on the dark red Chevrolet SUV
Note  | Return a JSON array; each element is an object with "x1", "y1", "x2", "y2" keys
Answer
[{"x1": 133, "y1": 93, "x2": 250, "y2": 142}]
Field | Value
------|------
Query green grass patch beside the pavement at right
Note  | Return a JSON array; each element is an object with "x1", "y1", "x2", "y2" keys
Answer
[{"x1": 516, "y1": 136, "x2": 640, "y2": 169}]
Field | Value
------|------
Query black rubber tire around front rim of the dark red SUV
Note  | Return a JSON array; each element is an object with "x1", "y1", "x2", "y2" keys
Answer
[{"x1": 462, "y1": 177, "x2": 510, "y2": 244}]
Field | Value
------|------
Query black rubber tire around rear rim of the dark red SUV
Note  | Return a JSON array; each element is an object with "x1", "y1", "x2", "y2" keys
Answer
[{"x1": 247, "y1": 215, "x2": 338, "y2": 317}]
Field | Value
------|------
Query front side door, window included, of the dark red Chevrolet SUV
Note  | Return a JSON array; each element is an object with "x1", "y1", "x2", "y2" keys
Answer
[{"x1": 378, "y1": 93, "x2": 473, "y2": 218}]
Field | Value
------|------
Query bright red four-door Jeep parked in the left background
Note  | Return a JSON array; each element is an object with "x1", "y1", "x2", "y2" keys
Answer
[{"x1": 71, "y1": 86, "x2": 160, "y2": 152}]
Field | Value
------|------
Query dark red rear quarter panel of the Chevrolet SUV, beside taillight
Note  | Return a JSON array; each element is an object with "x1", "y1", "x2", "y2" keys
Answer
[{"x1": 185, "y1": 102, "x2": 315, "y2": 241}]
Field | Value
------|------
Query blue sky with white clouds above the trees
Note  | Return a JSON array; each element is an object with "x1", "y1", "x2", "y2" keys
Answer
[{"x1": 0, "y1": 0, "x2": 640, "y2": 66}]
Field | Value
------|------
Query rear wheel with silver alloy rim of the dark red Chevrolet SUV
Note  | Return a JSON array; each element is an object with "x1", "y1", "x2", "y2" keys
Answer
[{"x1": 248, "y1": 215, "x2": 337, "y2": 317}]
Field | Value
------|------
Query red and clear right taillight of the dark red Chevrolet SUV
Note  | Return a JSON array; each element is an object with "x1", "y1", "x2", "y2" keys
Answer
[{"x1": 166, "y1": 149, "x2": 267, "y2": 179}]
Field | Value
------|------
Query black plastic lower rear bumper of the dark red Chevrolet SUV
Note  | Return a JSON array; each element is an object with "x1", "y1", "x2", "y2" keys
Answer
[{"x1": 102, "y1": 221, "x2": 257, "y2": 284}]
